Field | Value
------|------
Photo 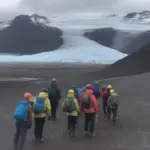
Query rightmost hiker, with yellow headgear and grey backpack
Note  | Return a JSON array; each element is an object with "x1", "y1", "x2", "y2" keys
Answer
[{"x1": 108, "y1": 89, "x2": 119, "y2": 124}]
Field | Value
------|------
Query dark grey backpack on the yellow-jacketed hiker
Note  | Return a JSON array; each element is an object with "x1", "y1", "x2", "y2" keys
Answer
[{"x1": 63, "y1": 99, "x2": 75, "y2": 113}]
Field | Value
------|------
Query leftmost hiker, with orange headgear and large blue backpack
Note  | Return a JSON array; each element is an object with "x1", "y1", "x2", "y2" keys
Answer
[{"x1": 14, "y1": 93, "x2": 32, "y2": 150}]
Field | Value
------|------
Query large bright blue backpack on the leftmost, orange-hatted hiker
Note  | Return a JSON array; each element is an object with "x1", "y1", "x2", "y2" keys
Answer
[{"x1": 14, "y1": 100, "x2": 29, "y2": 122}]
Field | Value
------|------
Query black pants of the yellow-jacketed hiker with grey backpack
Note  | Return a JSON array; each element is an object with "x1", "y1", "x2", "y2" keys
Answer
[{"x1": 68, "y1": 116, "x2": 77, "y2": 132}]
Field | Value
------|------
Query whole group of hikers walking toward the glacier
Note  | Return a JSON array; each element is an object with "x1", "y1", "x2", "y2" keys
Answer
[{"x1": 13, "y1": 78, "x2": 119, "y2": 150}]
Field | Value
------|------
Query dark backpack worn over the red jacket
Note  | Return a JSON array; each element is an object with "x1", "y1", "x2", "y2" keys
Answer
[{"x1": 81, "y1": 94, "x2": 91, "y2": 109}]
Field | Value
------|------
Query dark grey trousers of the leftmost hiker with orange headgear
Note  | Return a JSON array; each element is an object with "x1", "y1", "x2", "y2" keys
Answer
[{"x1": 14, "y1": 122, "x2": 28, "y2": 150}]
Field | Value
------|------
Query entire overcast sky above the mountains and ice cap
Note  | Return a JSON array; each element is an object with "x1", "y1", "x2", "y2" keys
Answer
[{"x1": 0, "y1": 0, "x2": 150, "y2": 18}]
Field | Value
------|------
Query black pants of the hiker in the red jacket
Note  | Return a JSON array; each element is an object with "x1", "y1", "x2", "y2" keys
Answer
[{"x1": 84, "y1": 113, "x2": 95, "y2": 133}]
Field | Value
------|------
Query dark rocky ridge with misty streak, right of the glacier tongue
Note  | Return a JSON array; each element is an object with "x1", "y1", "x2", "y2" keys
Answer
[{"x1": 84, "y1": 28, "x2": 150, "y2": 54}]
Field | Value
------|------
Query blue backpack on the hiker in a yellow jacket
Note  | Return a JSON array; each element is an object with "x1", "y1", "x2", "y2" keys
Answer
[{"x1": 33, "y1": 97, "x2": 45, "y2": 114}]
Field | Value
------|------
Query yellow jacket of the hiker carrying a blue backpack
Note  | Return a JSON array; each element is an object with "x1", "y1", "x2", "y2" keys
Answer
[{"x1": 32, "y1": 92, "x2": 51, "y2": 118}]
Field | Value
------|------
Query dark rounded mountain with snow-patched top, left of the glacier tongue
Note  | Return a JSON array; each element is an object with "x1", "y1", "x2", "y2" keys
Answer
[{"x1": 0, "y1": 15, "x2": 63, "y2": 55}]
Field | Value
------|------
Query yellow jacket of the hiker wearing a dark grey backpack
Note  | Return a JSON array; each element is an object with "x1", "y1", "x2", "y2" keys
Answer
[{"x1": 62, "y1": 94, "x2": 80, "y2": 116}]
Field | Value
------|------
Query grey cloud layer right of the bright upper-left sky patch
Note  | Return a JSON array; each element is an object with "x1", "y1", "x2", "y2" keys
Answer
[{"x1": 18, "y1": 0, "x2": 150, "y2": 15}]
